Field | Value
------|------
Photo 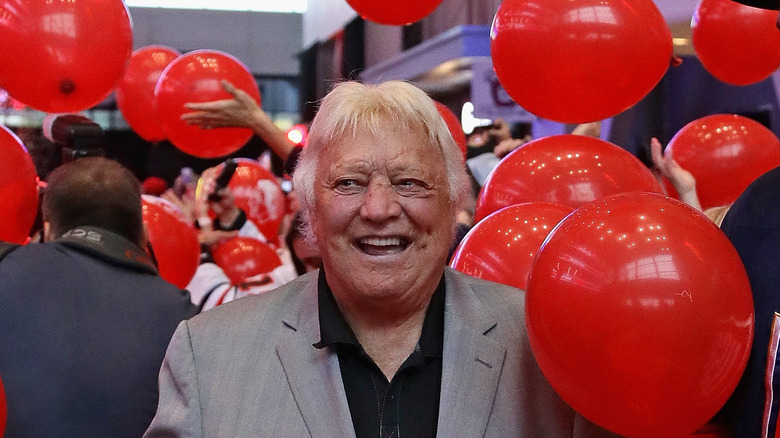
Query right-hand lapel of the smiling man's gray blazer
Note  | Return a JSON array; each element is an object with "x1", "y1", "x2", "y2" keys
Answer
[{"x1": 438, "y1": 269, "x2": 507, "y2": 437}]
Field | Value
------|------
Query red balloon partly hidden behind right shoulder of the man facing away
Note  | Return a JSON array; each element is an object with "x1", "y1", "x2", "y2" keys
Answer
[{"x1": 142, "y1": 195, "x2": 200, "y2": 289}]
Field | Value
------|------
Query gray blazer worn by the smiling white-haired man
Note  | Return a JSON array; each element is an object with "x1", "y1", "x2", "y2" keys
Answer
[{"x1": 145, "y1": 268, "x2": 620, "y2": 438}]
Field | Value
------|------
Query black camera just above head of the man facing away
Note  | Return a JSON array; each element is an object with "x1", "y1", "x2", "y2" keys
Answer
[{"x1": 43, "y1": 114, "x2": 105, "y2": 164}]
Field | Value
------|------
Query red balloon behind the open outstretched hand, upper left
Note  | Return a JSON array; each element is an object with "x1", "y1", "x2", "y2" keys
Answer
[{"x1": 154, "y1": 50, "x2": 260, "y2": 158}]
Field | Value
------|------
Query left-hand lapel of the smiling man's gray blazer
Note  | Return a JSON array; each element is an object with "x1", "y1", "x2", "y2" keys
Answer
[{"x1": 276, "y1": 275, "x2": 355, "y2": 437}]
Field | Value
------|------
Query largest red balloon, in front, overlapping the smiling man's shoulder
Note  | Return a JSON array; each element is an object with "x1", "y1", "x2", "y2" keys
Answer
[{"x1": 526, "y1": 193, "x2": 754, "y2": 438}]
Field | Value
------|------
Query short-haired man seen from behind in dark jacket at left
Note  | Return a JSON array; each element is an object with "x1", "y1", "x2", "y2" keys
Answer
[{"x1": 0, "y1": 157, "x2": 196, "y2": 438}]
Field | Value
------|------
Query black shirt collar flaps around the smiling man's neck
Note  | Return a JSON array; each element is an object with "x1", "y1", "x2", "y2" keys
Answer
[{"x1": 314, "y1": 269, "x2": 445, "y2": 357}]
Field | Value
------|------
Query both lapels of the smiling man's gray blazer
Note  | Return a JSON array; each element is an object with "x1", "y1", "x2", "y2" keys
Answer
[{"x1": 276, "y1": 268, "x2": 507, "y2": 437}]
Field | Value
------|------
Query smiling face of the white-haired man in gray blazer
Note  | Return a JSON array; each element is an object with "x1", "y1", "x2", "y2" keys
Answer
[{"x1": 311, "y1": 121, "x2": 456, "y2": 307}]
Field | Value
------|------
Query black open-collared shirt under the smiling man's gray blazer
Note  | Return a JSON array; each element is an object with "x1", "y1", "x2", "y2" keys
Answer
[{"x1": 314, "y1": 270, "x2": 444, "y2": 438}]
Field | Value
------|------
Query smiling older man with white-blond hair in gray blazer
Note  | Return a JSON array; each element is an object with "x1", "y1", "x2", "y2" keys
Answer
[{"x1": 146, "y1": 82, "x2": 606, "y2": 438}]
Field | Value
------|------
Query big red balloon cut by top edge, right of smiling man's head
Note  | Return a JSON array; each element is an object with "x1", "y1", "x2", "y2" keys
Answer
[{"x1": 490, "y1": 0, "x2": 672, "y2": 123}]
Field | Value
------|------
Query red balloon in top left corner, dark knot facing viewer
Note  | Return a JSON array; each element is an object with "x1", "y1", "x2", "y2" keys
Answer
[{"x1": 0, "y1": 0, "x2": 133, "y2": 113}]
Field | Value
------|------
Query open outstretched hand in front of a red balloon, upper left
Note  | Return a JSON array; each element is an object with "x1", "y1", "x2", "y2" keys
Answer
[{"x1": 181, "y1": 80, "x2": 265, "y2": 129}]
